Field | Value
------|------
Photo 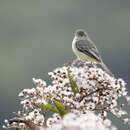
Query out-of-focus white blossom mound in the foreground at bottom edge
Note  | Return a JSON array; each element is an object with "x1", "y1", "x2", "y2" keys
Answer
[{"x1": 46, "y1": 111, "x2": 117, "y2": 130}]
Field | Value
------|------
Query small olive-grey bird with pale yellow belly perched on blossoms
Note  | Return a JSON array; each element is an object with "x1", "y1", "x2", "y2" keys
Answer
[{"x1": 72, "y1": 29, "x2": 114, "y2": 77}]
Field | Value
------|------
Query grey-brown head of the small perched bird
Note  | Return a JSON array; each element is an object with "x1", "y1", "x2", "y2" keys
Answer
[{"x1": 74, "y1": 29, "x2": 88, "y2": 40}]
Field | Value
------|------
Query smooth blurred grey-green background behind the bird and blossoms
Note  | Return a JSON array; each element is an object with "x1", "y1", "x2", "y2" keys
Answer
[{"x1": 0, "y1": 0, "x2": 130, "y2": 130}]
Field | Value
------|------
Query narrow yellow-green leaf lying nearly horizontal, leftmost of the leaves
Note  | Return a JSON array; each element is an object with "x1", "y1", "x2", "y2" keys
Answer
[{"x1": 35, "y1": 104, "x2": 59, "y2": 113}]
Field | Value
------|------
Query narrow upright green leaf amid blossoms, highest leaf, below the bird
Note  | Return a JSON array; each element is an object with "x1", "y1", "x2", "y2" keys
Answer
[{"x1": 67, "y1": 70, "x2": 79, "y2": 95}]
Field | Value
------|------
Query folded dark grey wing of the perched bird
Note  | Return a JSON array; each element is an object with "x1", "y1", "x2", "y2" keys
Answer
[{"x1": 76, "y1": 40, "x2": 101, "y2": 62}]
